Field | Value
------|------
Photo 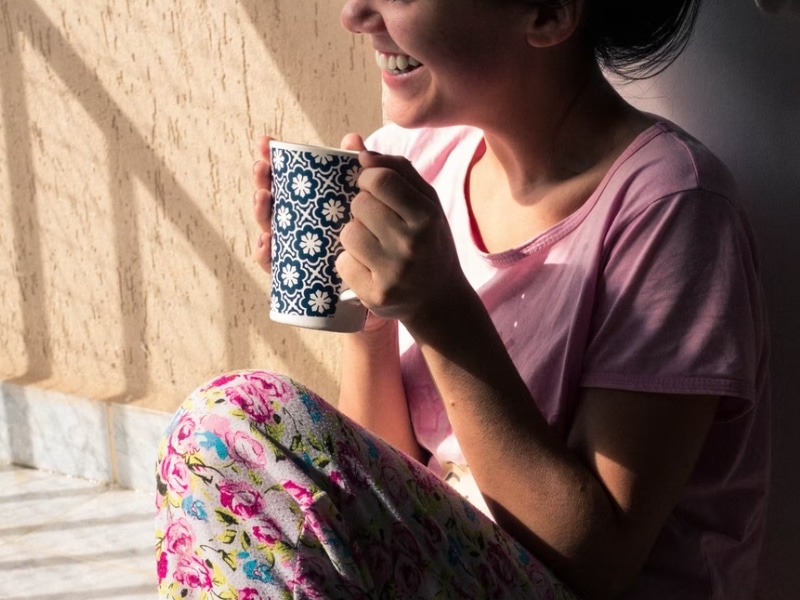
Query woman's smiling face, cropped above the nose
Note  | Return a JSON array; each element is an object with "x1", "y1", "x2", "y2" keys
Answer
[{"x1": 342, "y1": 0, "x2": 529, "y2": 127}]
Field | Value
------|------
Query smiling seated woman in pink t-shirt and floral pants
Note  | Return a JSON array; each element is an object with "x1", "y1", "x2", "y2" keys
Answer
[{"x1": 158, "y1": 0, "x2": 769, "y2": 599}]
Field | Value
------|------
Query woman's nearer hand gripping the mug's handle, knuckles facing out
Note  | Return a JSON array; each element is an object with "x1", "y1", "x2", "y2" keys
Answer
[{"x1": 336, "y1": 150, "x2": 472, "y2": 338}]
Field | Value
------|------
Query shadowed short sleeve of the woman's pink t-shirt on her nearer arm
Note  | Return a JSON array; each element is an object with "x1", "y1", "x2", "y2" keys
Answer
[{"x1": 581, "y1": 190, "x2": 764, "y2": 418}]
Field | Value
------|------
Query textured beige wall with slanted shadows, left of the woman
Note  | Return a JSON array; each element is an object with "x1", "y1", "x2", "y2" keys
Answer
[{"x1": 0, "y1": 0, "x2": 380, "y2": 410}]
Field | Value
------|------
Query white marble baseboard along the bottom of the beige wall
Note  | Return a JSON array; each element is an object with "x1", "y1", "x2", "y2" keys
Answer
[{"x1": 0, "y1": 382, "x2": 171, "y2": 491}]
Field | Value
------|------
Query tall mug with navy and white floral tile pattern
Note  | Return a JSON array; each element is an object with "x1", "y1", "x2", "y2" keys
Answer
[{"x1": 269, "y1": 140, "x2": 367, "y2": 332}]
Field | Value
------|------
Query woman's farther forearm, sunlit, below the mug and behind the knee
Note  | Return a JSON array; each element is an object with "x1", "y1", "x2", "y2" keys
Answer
[{"x1": 339, "y1": 322, "x2": 423, "y2": 460}]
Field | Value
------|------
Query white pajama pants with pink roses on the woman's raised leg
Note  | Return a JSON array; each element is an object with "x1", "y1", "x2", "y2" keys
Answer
[{"x1": 156, "y1": 371, "x2": 575, "y2": 600}]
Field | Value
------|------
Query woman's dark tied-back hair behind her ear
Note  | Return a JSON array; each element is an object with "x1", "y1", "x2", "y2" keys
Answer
[{"x1": 584, "y1": 0, "x2": 702, "y2": 79}]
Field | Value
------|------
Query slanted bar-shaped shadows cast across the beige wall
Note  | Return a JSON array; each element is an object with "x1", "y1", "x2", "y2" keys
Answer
[{"x1": 0, "y1": 0, "x2": 372, "y2": 400}]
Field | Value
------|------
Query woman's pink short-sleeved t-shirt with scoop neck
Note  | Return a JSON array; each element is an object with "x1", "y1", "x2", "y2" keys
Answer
[{"x1": 368, "y1": 122, "x2": 769, "y2": 600}]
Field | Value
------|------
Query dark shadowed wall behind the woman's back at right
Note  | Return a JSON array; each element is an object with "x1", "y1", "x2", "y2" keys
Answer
[{"x1": 623, "y1": 0, "x2": 800, "y2": 600}]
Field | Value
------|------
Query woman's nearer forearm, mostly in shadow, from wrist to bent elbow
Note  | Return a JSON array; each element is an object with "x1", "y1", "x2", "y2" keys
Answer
[{"x1": 412, "y1": 292, "x2": 624, "y2": 592}]
